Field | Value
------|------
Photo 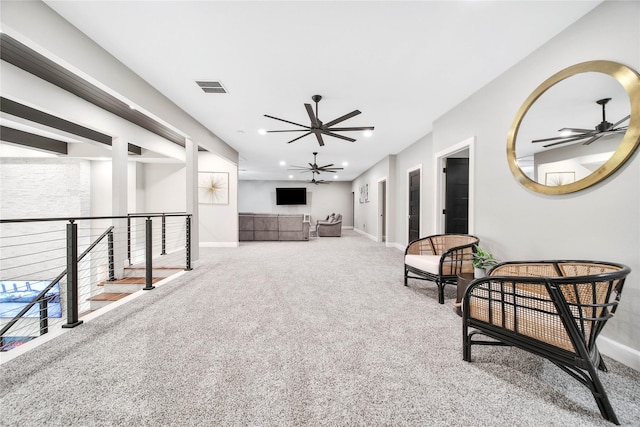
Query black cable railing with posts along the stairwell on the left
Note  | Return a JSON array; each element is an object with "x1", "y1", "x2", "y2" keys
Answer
[{"x1": 0, "y1": 212, "x2": 191, "y2": 351}]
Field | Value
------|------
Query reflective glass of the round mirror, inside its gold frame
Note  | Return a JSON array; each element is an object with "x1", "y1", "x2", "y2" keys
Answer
[{"x1": 515, "y1": 72, "x2": 631, "y2": 186}]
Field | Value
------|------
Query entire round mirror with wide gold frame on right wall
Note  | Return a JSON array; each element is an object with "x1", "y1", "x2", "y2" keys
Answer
[{"x1": 507, "y1": 61, "x2": 640, "y2": 194}]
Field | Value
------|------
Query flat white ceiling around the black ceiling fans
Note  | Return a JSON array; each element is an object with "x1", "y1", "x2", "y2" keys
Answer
[{"x1": 46, "y1": 1, "x2": 600, "y2": 181}]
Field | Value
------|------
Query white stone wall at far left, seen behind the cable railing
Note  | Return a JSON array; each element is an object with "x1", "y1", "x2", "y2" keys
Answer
[{"x1": 0, "y1": 158, "x2": 91, "y2": 335}]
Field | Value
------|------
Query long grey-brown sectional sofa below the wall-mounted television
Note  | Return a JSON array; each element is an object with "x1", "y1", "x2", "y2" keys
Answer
[{"x1": 239, "y1": 213, "x2": 309, "y2": 241}]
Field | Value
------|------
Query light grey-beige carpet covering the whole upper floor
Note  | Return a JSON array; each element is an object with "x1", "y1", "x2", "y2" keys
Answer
[{"x1": 0, "y1": 230, "x2": 640, "y2": 427}]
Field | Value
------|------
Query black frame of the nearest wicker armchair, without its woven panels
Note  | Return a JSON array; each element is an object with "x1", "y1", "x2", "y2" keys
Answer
[{"x1": 462, "y1": 261, "x2": 630, "y2": 424}]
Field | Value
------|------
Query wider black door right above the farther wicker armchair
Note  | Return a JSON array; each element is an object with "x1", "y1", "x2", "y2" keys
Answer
[{"x1": 444, "y1": 158, "x2": 469, "y2": 234}]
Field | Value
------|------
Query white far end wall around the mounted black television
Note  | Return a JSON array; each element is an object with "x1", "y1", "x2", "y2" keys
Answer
[{"x1": 238, "y1": 180, "x2": 353, "y2": 227}]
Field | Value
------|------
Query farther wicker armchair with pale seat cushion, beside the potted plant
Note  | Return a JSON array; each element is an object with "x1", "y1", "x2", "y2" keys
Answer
[{"x1": 404, "y1": 234, "x2": 479, "y2": 304}]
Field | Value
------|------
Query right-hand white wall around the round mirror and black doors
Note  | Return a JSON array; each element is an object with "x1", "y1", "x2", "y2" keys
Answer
[{"x1": 356, "y1": 2, "x2": 640, "y2": 370}]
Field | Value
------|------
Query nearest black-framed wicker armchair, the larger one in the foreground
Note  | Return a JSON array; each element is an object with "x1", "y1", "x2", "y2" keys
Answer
[{"x1": 462, "y1": 261, "x2": 630, "y2": 424}]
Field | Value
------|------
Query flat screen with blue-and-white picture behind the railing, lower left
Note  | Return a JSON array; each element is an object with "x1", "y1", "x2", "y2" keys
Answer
[{"x1": 0, "y1": 280, "x2": 62, "y2": 318}]
